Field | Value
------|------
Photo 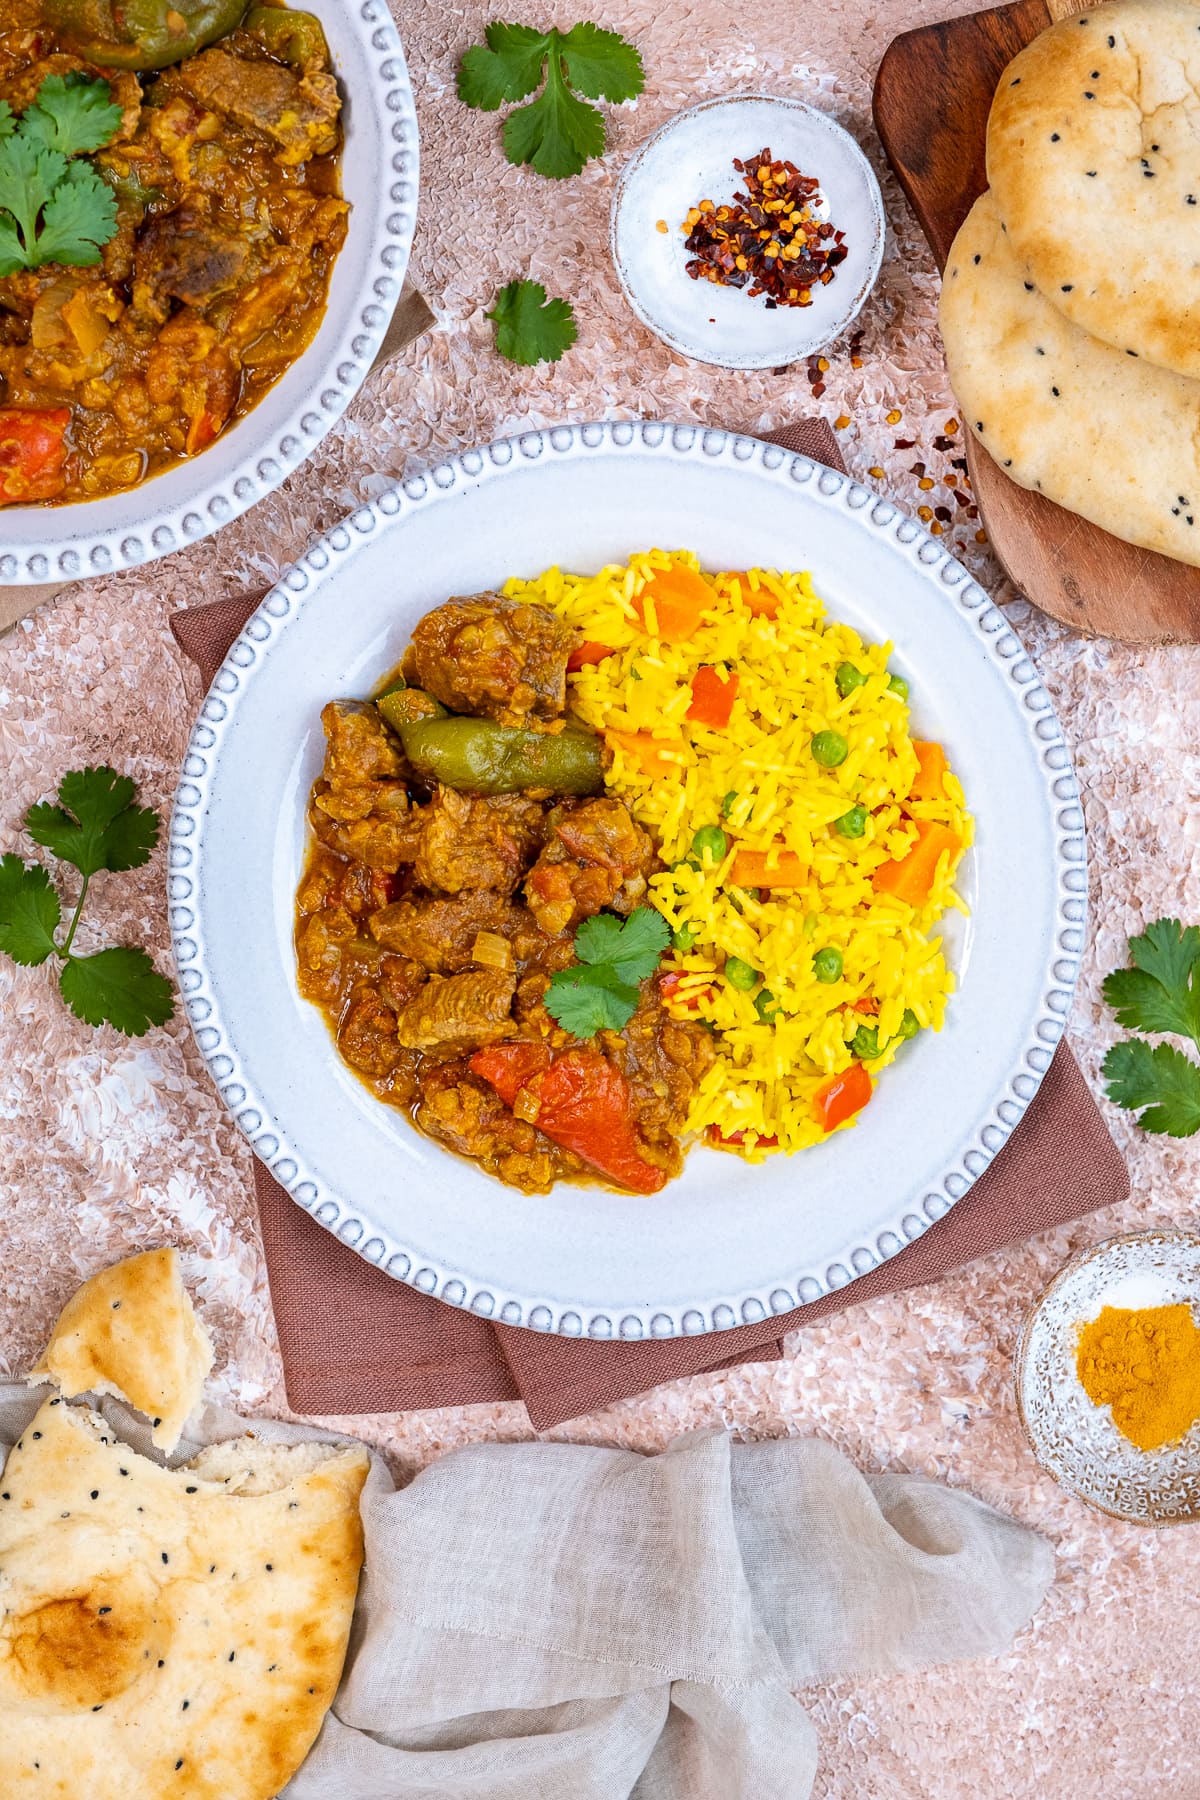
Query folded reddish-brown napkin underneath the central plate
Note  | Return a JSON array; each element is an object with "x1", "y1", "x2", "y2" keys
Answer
[{"x1": 171, "y1": 419, "x2": 1130, "y2": 1431}]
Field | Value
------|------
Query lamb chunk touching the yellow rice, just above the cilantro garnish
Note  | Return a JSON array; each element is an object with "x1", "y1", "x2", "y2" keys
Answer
[{"x1": 525, "y1": 799, "x2": 658, "y2": 936}]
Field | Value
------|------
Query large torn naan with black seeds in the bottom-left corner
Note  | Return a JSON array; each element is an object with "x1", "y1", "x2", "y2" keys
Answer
[{"x1": 0, "y1": 1400, "x2": 369, "y2": 1800}]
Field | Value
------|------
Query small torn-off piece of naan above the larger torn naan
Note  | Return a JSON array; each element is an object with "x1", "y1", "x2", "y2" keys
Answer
[{"x1": 29, "y1": 1249, "x2": 212, "y2": 1456}]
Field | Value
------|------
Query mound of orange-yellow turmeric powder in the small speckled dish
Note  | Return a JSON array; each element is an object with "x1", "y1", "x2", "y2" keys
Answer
[{"x1": 1076, "y1": 1303, "x2": 1200, "y2": 1451}]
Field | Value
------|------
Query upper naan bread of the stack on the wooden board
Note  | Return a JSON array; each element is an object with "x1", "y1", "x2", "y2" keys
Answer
[{"x1": 988, "y1": 0, "x2": 1200, "y2": 374}]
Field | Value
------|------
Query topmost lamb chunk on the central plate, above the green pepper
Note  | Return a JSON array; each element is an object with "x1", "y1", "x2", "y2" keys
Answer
[{"x1": 405, "y1": 594, "x2": 576, "y2": 725}]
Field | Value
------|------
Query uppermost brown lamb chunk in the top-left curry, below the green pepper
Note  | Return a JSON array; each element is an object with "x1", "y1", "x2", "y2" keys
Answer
[{"x1": 178, "y1": 49, "x2": 342, "y2": 167}]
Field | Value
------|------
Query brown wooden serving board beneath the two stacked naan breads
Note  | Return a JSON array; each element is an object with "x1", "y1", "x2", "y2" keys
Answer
[{"x1": 874, "y1": 0, "x2": 1200, "y2": 644}]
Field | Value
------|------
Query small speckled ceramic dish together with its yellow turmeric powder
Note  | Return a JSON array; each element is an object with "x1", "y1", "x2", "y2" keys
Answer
[{"x1": 1015, "y1": 1231, "x2": 1200, "y2": 1525}]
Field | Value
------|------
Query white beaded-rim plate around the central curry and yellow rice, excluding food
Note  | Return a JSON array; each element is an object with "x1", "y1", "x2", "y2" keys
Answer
[{"x1": 169, "y1": 423, "x2": 1087, "y2": 1337}]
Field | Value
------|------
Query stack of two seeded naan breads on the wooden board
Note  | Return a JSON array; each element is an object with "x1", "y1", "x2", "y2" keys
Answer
[{"x1": 941, "y1": 0, "x2": 1200, "y2": 565}]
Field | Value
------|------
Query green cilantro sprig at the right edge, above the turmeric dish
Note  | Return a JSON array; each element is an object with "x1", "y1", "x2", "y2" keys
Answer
[{"x1": 1103, "y1": 918, "x2": 1200, "y2": 1138}]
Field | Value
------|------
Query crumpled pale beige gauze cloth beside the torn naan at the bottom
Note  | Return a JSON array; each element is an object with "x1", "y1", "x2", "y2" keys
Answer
[{"x1": 0, "y1": 1384, "x2": 1054, "y2": 1800}]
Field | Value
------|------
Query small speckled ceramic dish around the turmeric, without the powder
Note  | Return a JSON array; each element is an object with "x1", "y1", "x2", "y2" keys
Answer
[{"x1": 1015, "y1": 1231, "x2": 1200, "y2": 1525}]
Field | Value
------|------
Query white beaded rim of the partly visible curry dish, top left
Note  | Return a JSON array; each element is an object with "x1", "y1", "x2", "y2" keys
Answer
[{"x1": 0, "y1": 0, "x2": 417, "y2": 587}]
